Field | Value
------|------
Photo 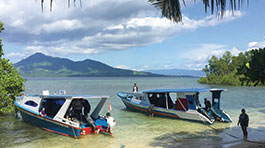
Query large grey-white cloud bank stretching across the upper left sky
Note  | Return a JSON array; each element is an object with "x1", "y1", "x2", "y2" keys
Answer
[{"x1": 0, "y1": 0, "x2": 243, "y2": 64}]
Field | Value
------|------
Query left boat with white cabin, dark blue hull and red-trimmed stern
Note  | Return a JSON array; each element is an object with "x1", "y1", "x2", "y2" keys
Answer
[{"x1": 15, "y1": 93, "x2": 109, "y2": 138}]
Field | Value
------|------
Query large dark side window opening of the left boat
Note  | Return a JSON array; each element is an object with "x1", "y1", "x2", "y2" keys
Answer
[{"x1": 39, "y1": 98, "x2": 65, "y2": 118}]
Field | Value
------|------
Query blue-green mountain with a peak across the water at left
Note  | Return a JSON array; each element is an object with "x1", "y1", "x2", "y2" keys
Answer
[{"x1": 14, "y1": 53, "x2": 164, "y2": 77}]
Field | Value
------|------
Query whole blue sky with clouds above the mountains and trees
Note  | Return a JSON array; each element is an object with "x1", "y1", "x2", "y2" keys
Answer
[{"x1": 0, "y1": 0, "x2": 265, "y2": 70}]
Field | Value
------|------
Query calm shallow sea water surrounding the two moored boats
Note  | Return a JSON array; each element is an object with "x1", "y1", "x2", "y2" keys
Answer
[{"x1": 0, "y1": 77, "x2": 265, "y2": 148}]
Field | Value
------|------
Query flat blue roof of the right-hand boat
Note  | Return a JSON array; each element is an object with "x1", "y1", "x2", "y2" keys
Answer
[{"x1": 143, "y1": 88, "x2": 225, "y2": 93}]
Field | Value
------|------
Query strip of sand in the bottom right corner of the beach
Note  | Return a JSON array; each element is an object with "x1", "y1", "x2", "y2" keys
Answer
[{"x1": 229, "y1": 140, "x2": 265, "y2": 148}]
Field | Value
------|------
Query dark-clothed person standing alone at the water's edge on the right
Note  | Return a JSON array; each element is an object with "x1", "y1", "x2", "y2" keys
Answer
[{"x1": 237, "y1": 109, "x2": 249, "y2": 140}]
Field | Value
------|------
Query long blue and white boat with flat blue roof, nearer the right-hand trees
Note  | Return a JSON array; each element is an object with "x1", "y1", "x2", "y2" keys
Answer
[{"x1": 117, "y1": 89, "x2": 232, "y2": 124}]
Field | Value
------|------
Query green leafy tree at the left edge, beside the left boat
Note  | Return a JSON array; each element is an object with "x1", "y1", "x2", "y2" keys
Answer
[{"x1": 0, "y1": 22, "x2": 25, "y2": 115}]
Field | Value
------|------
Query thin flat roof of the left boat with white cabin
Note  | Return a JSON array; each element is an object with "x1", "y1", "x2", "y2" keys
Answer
[{"x1": 29, "y1": 95, "x2": 109, "y2": 99}]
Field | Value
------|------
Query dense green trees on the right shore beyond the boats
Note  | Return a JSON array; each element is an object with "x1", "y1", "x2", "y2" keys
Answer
[{"x1": 198, "y1": 48, "x2": 265, "y2": 86}]
